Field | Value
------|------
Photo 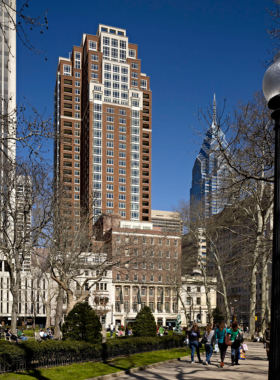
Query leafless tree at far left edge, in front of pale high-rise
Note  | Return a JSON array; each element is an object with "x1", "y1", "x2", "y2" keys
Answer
[{"x1": 0, "y1": 161, "x2": 50, "y2": 332}]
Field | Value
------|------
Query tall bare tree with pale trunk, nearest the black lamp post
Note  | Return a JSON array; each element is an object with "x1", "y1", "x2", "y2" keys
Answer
[{"x1": 198, "y1": 91, "x2": 274, "y2": 336}]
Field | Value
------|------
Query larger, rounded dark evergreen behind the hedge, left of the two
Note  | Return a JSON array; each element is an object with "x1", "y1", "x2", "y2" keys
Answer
[{"x1": 62, "y1": 302, "x2": 102, "y2": 343}]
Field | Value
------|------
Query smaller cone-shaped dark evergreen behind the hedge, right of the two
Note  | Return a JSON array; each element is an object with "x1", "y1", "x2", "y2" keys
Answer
[{"x1": 133, "y1": 306, "x2": 157, "y2": 336}]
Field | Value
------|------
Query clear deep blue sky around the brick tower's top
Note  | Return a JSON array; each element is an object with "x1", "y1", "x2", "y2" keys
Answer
[{"x1": 17, "y1": 0, "x2": 273, "y2": 210}]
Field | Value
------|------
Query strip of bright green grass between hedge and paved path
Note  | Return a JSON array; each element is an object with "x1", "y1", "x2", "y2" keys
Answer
[{"x1": 0, "y1": 348, "x2": 194, "y2": 380}]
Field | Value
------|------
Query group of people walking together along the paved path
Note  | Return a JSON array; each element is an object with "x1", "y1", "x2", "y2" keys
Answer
[{"x1": 187, "y1": 321, "x2": 243, "y2": 368}]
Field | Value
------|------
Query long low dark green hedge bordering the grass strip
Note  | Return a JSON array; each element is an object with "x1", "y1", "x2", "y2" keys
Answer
[{"x1": 0, "y1": 335, "x2": 185, "y2": 368}]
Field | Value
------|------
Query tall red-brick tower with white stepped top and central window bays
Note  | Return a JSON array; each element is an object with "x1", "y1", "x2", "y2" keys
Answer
[{"x1": 54, "y1": 25, "x2": 152, "y2": 222}]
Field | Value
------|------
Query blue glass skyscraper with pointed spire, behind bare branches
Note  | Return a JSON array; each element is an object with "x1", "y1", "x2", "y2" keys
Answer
[{"x1": 190, "y1": 95, "x2": 227, "y2": 217}]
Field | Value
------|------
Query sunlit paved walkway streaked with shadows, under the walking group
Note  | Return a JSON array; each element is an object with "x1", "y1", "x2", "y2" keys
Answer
[{"x1": 116, "y1": 343, "x2": 268, "y2": 380}]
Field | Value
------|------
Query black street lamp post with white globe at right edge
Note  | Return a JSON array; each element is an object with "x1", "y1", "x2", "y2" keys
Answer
[{"x1": 263, "y1": 53, "x2": 280, "y2": 380}]
